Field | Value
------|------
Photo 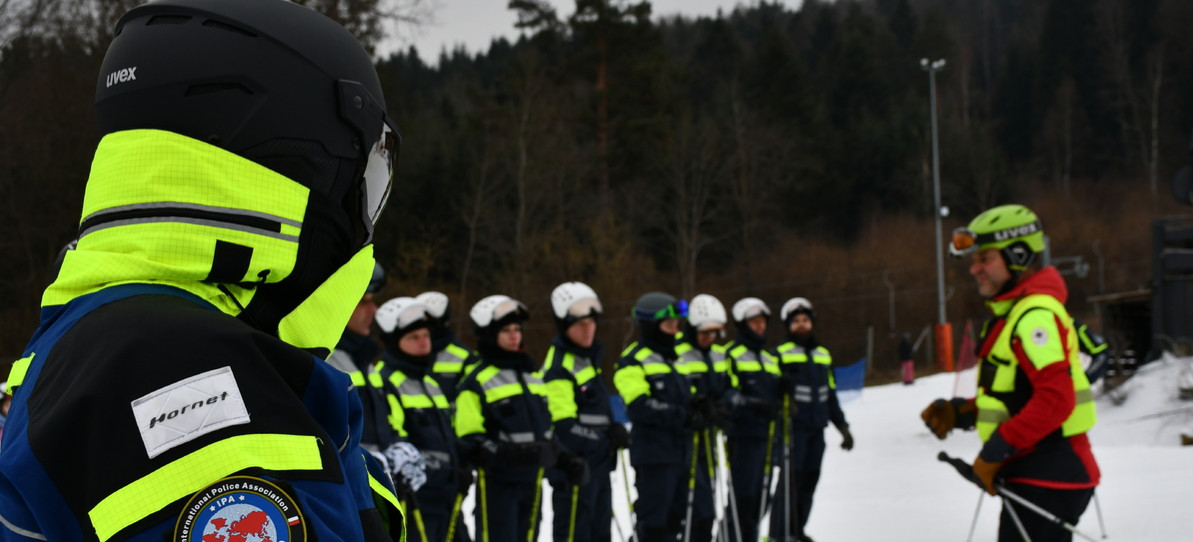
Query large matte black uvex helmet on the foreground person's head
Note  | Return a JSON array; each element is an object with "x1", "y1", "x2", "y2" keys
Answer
[{"x1": 95, "y1": 0, "x2": 400, "y2": 246}]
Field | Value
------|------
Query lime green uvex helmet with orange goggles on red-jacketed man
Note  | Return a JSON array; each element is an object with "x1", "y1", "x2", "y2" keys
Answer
[{"x1": 948, "y1": 204, "x2": 1044, "y2": 272}]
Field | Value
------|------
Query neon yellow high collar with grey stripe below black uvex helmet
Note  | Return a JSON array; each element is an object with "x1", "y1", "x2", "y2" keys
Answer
[{"x1": 42, "y1": 130, "x2": 375, "y2": 356}]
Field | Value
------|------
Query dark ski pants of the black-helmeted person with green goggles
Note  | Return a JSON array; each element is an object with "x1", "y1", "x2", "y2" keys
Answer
[{"x1": 633, "y1": 462, "x2": 691, "y2": 542}]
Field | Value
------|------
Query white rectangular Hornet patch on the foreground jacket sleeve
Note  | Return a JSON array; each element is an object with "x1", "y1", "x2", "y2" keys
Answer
[{"x1": 132, "y1": 367, "x2": 249, "y2": 457}]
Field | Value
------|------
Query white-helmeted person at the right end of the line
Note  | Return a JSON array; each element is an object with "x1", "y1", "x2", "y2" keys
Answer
[{"x1": 771, "y1": 297, "x2": 853, "y2": 542}]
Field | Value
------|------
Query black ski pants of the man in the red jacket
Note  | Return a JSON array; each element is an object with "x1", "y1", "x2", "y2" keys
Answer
[{"x1": 999, "y1": 484, "x2": 1094, "y2": 542}]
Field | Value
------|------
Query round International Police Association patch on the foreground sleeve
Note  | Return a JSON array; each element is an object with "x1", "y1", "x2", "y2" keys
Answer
[{"x1": 173, "y1": 476, "x2": 307, "y2": 542}]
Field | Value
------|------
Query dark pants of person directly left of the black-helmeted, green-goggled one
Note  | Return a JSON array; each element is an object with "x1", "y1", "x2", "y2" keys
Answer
[{"x1": 550, "y1": 455, "x2": 616, "y2": 542}]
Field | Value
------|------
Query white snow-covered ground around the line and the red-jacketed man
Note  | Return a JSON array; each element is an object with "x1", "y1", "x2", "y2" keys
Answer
[{"x1": 466, "y1": 356, "x2": 1193, "y2": 542}]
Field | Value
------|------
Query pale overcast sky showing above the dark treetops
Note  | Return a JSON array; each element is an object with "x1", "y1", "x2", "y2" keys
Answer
[{"x1": 378, "y1": 0, "x2": 801, "y2": 63}]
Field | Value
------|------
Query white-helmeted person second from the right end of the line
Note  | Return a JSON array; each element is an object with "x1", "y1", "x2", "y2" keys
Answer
[{"x1": 725, "y1": 297, "x2": 781, "y2": 541}]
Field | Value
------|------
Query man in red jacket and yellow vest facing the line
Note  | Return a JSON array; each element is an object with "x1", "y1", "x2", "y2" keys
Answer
[{"x1": 920, "y1": 205, "x2": 1101, "y2": 542}]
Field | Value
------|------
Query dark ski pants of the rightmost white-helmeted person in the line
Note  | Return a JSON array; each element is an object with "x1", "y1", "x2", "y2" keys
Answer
[{"x1": 771, "y1": 429, "x2": 824, "y2": 540}]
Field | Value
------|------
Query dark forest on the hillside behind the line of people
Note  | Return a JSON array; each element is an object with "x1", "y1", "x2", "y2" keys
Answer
[{"x1": 0, "y1": 0, "x2": 1193, "y2": 375}]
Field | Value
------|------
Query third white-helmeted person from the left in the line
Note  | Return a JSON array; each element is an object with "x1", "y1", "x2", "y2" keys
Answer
[{"x1": 455, "y1": 295, "x2": 589, "y2": 542}]
